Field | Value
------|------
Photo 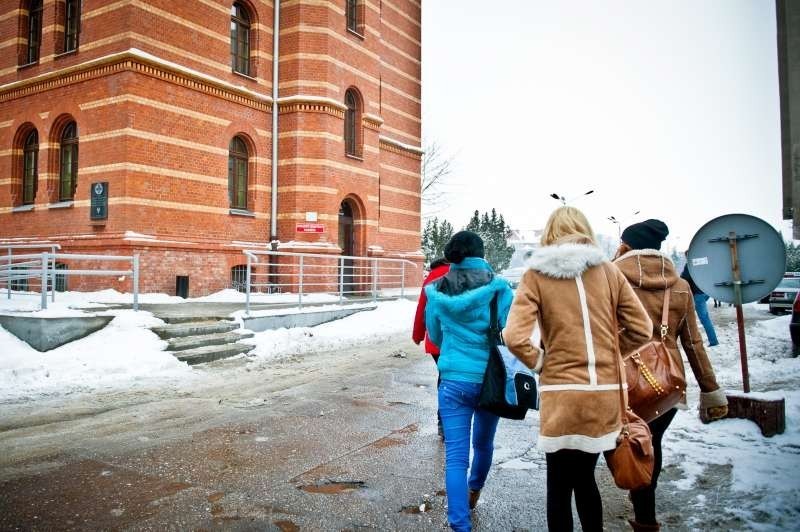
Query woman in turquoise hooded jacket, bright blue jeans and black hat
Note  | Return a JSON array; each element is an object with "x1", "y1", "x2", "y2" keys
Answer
[{"x1": 425, "y1": 231, "x2": 513, "y2": 531}]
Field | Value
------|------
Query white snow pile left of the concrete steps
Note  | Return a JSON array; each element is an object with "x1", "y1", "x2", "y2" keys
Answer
[{"x1": 0, "y1": 310, "x2": 193, "y2": 402}]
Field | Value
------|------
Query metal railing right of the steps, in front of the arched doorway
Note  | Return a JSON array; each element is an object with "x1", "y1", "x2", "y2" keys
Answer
[{"x1": 243, "y1": 249, "x2": 422, "y2": 314}]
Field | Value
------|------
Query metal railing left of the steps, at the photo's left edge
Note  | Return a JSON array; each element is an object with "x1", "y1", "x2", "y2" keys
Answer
[{"x1": 0, "y1": 250, "x2": 139, "y2": 310}]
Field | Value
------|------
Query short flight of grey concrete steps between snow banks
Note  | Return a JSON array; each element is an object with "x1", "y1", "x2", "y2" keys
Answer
[{"x1": 151, "y1": 316, "x2": 254, "y2": 365}]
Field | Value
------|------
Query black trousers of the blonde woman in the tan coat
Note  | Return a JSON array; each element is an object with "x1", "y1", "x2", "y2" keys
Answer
[{"x1": 545, "y1": 449, "x2": 603, "y2": 532}]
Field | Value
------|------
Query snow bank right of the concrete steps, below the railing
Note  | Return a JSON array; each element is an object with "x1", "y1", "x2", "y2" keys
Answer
[{"x1": 243, "y1": 299, "x2": 417, "y2": 361}]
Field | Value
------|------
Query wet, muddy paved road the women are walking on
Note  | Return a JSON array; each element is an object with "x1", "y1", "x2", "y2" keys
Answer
[{"x1": 0, "y1": 338, "x2": 720, "y2": 531}]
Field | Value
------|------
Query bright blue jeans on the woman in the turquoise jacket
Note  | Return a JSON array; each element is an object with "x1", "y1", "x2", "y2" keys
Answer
[{"x1": 439, "y1": 379, "x2": 500, "y2": 531}]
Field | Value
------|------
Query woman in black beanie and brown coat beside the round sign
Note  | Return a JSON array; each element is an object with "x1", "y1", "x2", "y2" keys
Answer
[{"x1": 614, "y1": 220, "x2": 728, "y2": 532}]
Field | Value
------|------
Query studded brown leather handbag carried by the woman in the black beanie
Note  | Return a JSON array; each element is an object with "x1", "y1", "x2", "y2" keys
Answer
[{"x1": 622, "y1": 288, "x2": 686, "y2": 423}]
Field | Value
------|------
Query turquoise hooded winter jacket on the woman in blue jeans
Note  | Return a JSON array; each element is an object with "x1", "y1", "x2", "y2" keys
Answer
[{"x1": 425, "y1": 257, "x2": 513, "y2": 382}]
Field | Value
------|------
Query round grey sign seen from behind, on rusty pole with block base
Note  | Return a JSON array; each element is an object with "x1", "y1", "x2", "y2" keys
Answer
[{"x1": 686, "y1": 214, "x2": 786, "y2": 436}]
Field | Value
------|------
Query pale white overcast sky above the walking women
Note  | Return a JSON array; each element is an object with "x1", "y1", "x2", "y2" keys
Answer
[{"x1": 422, "y1": 0, "x2": 788, "y2": 249}]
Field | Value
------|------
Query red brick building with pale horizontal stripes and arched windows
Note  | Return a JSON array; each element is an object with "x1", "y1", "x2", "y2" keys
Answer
[{"x1": 0, "y1": 0, "x2": 421, "y2": 295}]
